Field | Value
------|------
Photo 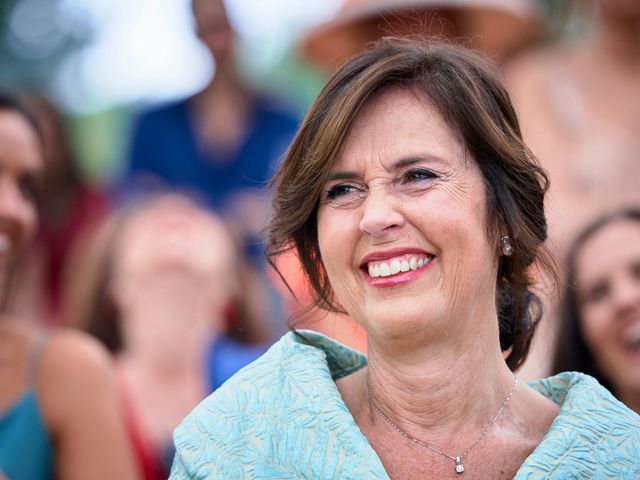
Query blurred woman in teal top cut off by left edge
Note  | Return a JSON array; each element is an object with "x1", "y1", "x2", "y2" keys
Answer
[{"x1": 0, "y1": 96, "x2": 135, "y2": 480}]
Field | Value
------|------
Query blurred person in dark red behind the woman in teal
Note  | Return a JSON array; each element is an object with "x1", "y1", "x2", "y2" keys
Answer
[{"x1": 16, "y1": 94, "x2": 108, "y2": 325}]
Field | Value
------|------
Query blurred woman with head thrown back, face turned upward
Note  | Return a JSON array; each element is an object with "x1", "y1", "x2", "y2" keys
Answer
[{"x1": 68, "y1": 194, "x2": 266, "y2": 479}]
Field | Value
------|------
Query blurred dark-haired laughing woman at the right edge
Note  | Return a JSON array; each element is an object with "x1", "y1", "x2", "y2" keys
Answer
[{"x1": 554, "y1": 208, "x2": 640, "y2": 413}]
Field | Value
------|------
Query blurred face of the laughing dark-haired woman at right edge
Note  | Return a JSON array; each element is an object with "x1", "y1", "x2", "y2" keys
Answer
[{"x1": 576, "y1": 220, "x2": 640, "y2": 391}]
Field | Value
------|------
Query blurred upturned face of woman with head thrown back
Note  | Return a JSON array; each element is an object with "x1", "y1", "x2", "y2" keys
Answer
[{"x1": 110, "y1": 196, "x2": 238, "y2": 356}]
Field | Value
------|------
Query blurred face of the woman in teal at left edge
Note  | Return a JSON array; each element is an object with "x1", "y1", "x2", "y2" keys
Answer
[{"x1": 0, "y1": 109, "x2": 44, "y2": 276}]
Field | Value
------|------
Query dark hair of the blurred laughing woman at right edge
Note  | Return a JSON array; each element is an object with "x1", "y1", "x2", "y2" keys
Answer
[{"x1": 553, "y1": 207, "x2": 640, "y2": 389}]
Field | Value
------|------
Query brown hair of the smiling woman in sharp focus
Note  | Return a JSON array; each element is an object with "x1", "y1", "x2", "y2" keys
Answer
[{"x1": 267, "y1": 38, "x2": 553, "y2": 369}]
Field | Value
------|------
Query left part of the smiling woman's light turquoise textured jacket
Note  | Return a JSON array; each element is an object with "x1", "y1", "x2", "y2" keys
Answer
[{"x1": 171, "y1": 332, "x2": 376, "y2": 478}]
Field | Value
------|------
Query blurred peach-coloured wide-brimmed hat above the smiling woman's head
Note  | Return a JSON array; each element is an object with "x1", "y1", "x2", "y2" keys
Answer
[{"x1": 299, "y1": 0, "x2": 536, "y2": 72}]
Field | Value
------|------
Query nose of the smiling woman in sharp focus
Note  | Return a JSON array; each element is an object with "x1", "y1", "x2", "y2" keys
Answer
[{"x1": 360, "y1": 190, "x2": 405, "y2": 238}]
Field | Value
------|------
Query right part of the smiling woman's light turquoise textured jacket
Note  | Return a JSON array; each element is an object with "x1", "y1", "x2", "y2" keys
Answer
[{"x1": 516, "y1": 372, "x2": 640, "y2": 478}]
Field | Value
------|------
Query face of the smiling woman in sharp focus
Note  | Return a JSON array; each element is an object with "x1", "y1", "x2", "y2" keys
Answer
[{"x1": 318, "y1": 89, "x2": 497, "y2": 341}]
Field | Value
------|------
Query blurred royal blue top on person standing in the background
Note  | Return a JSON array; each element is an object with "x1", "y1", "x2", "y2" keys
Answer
[{"x1": 122, "y1": 98, "x2": 299, "y2": 215}]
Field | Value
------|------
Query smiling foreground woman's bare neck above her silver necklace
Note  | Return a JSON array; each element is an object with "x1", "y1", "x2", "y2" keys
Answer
[{"x1": 365, "y1": 326, "x2": 514, "y2": 438}]
